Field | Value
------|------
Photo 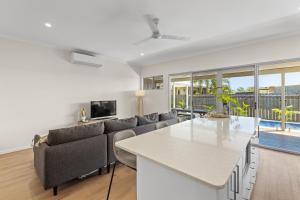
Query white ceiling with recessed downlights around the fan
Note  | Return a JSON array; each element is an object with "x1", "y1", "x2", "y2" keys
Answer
[{"x1": 0, "y1": 0, "x2": 300, "y2": 65}]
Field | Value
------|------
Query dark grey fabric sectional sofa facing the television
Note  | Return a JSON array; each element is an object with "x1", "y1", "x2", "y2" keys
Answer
[{"x1": 33, "y1": 112, "x2": 178, "y2": 195}]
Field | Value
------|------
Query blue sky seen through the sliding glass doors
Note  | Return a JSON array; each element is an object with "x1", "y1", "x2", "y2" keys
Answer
[{"x1": 229, "y1": 72, "x2": 300, "y2": 90}]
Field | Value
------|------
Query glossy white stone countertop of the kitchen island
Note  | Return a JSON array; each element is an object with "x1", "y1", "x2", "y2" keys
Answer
[{"x1": 116, "y1": 116, "x2": 255, "y2": 188}]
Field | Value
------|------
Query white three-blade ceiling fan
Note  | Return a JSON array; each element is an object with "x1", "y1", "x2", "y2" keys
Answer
[{"x1": 134, "y1": 15, "x2": 190, "y2": 45}]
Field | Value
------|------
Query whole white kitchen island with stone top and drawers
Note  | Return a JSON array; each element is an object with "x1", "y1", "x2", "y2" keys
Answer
[{"x1": 116, "y1": 116, "x2": 258, "y2": 200}]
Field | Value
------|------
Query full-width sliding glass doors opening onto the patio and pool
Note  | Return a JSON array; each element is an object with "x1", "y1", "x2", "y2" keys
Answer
[{"x1": 169, "y1": 62, "x2": 300, "y2": 153}]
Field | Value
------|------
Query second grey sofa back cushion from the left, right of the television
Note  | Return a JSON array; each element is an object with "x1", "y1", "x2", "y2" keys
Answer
[{"x1": 104, "y1": 117, "x2": 137, "y2": 133}]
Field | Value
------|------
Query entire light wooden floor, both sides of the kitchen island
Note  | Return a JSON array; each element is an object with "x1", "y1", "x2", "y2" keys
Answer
[{"x1": 0, "y1": 149, "x2": 300, "y2": 200}]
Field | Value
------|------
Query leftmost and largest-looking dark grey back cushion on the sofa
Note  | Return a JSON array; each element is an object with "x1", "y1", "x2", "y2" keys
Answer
[{"x1": 47, "y1": 122, "x2": 104, "y2": 146}]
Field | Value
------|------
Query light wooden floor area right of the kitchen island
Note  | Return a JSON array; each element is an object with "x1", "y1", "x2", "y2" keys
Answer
[{"x1": 252, "y1": 149, "x2": 300, "y2": 200}]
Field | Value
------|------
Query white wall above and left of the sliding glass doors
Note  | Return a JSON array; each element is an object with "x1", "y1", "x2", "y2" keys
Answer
[{"x1": 141, "y1": 35, "x2": 300, "y2": 113}]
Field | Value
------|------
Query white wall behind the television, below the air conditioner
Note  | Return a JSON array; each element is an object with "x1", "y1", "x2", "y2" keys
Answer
[{"x1": 0, "y1": 39, "x2": 139, "y2": 153}]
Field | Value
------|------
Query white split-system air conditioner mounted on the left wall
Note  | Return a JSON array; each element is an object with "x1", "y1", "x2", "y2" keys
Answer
[{"x1": 71, "y1": 51, "x2": 102, "y2": 67}]
